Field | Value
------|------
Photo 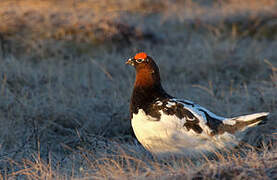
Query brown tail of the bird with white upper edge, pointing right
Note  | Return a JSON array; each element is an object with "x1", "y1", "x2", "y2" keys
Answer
[{"x1": 223, "y1": 112, "x2": 269, "y2": 134}]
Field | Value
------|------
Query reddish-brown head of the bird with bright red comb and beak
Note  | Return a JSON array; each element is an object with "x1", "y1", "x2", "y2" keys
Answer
[{"x1": 126, "y1": 52, "x2": 160, "y2": 86}]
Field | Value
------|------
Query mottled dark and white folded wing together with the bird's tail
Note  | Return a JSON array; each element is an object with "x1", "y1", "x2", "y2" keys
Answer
[{"x1": 160, "y1": 99, "x2": 269, "y2": 136}]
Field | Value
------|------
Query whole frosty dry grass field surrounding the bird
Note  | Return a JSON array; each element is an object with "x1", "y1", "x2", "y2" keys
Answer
[{"x1": 0, "y1": 0, "x2": 277, "y2": 179}]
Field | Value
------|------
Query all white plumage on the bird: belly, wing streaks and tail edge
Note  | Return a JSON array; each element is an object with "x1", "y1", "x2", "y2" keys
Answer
[{"x1": 131, "y1": 99, "x2": 268, "y2": 156}]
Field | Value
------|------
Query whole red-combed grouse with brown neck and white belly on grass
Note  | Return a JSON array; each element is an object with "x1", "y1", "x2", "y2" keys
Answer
[{"x1": 126, "y1": 52, "x2": 269, "y2": 156}]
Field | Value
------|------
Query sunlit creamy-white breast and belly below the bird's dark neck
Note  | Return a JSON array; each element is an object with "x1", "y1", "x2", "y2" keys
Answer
[{"x1": 131, "y1": 109, "x2": 222, "y2": 155}]
